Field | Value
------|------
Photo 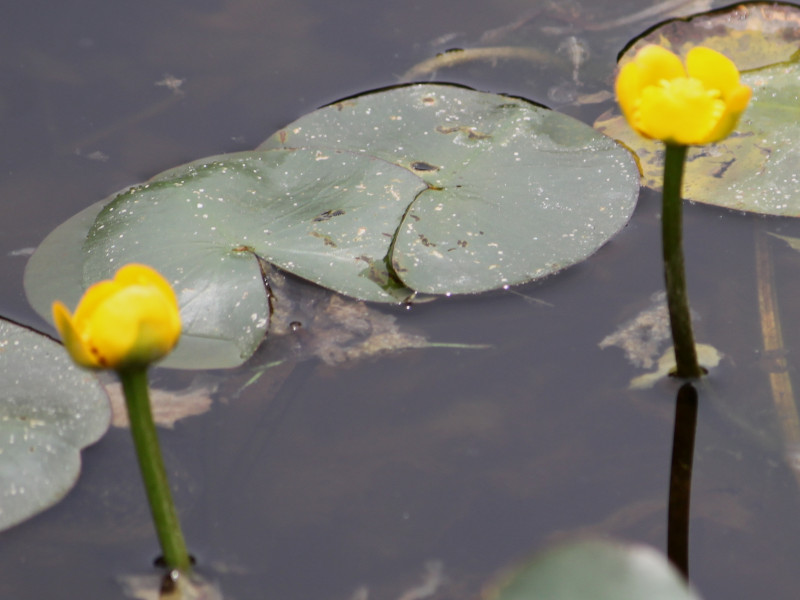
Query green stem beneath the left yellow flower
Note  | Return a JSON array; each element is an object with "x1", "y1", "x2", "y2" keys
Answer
[{"x1": 118, "y1": 367, "x2": 191, "y2": 571}]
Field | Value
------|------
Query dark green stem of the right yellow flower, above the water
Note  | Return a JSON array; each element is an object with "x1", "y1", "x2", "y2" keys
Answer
[{"x1": 661, "y1": 144, "x2": 703, "y2": 379}]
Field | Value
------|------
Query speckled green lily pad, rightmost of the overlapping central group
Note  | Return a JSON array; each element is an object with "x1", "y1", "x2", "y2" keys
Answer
[{"x1": 260, "y1": 85, "x2": 638, "y2": 294}]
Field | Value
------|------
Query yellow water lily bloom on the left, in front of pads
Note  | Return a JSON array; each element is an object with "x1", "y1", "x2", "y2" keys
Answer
[{"x1": 53, "y1": 264, "x2": 181, "y2": 370}]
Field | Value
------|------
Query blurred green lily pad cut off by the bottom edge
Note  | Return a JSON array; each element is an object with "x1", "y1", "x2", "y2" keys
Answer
[{"x1": 485, "y1": 541, "x2": 699, "y2": 600}]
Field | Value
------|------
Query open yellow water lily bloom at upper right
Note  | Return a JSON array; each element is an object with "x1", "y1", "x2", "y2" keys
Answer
[{"x1": 616, "y1": 45, "x2": 752, "y2": 146}]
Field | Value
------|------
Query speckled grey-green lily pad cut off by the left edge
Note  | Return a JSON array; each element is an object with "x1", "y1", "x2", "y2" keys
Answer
[{"x1": 0, "y1": 320, "x2": 111, "y2": 530}]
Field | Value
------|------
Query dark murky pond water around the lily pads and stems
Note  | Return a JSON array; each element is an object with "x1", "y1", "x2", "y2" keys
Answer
[{"x1": 0, "y1": 0, "x2": 800, "y2": 600}]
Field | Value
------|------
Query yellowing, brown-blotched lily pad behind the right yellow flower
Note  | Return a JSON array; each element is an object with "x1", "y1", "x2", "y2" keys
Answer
[{"x1": 595, "y1": 3, "x2": 800, "y2": 217}]
